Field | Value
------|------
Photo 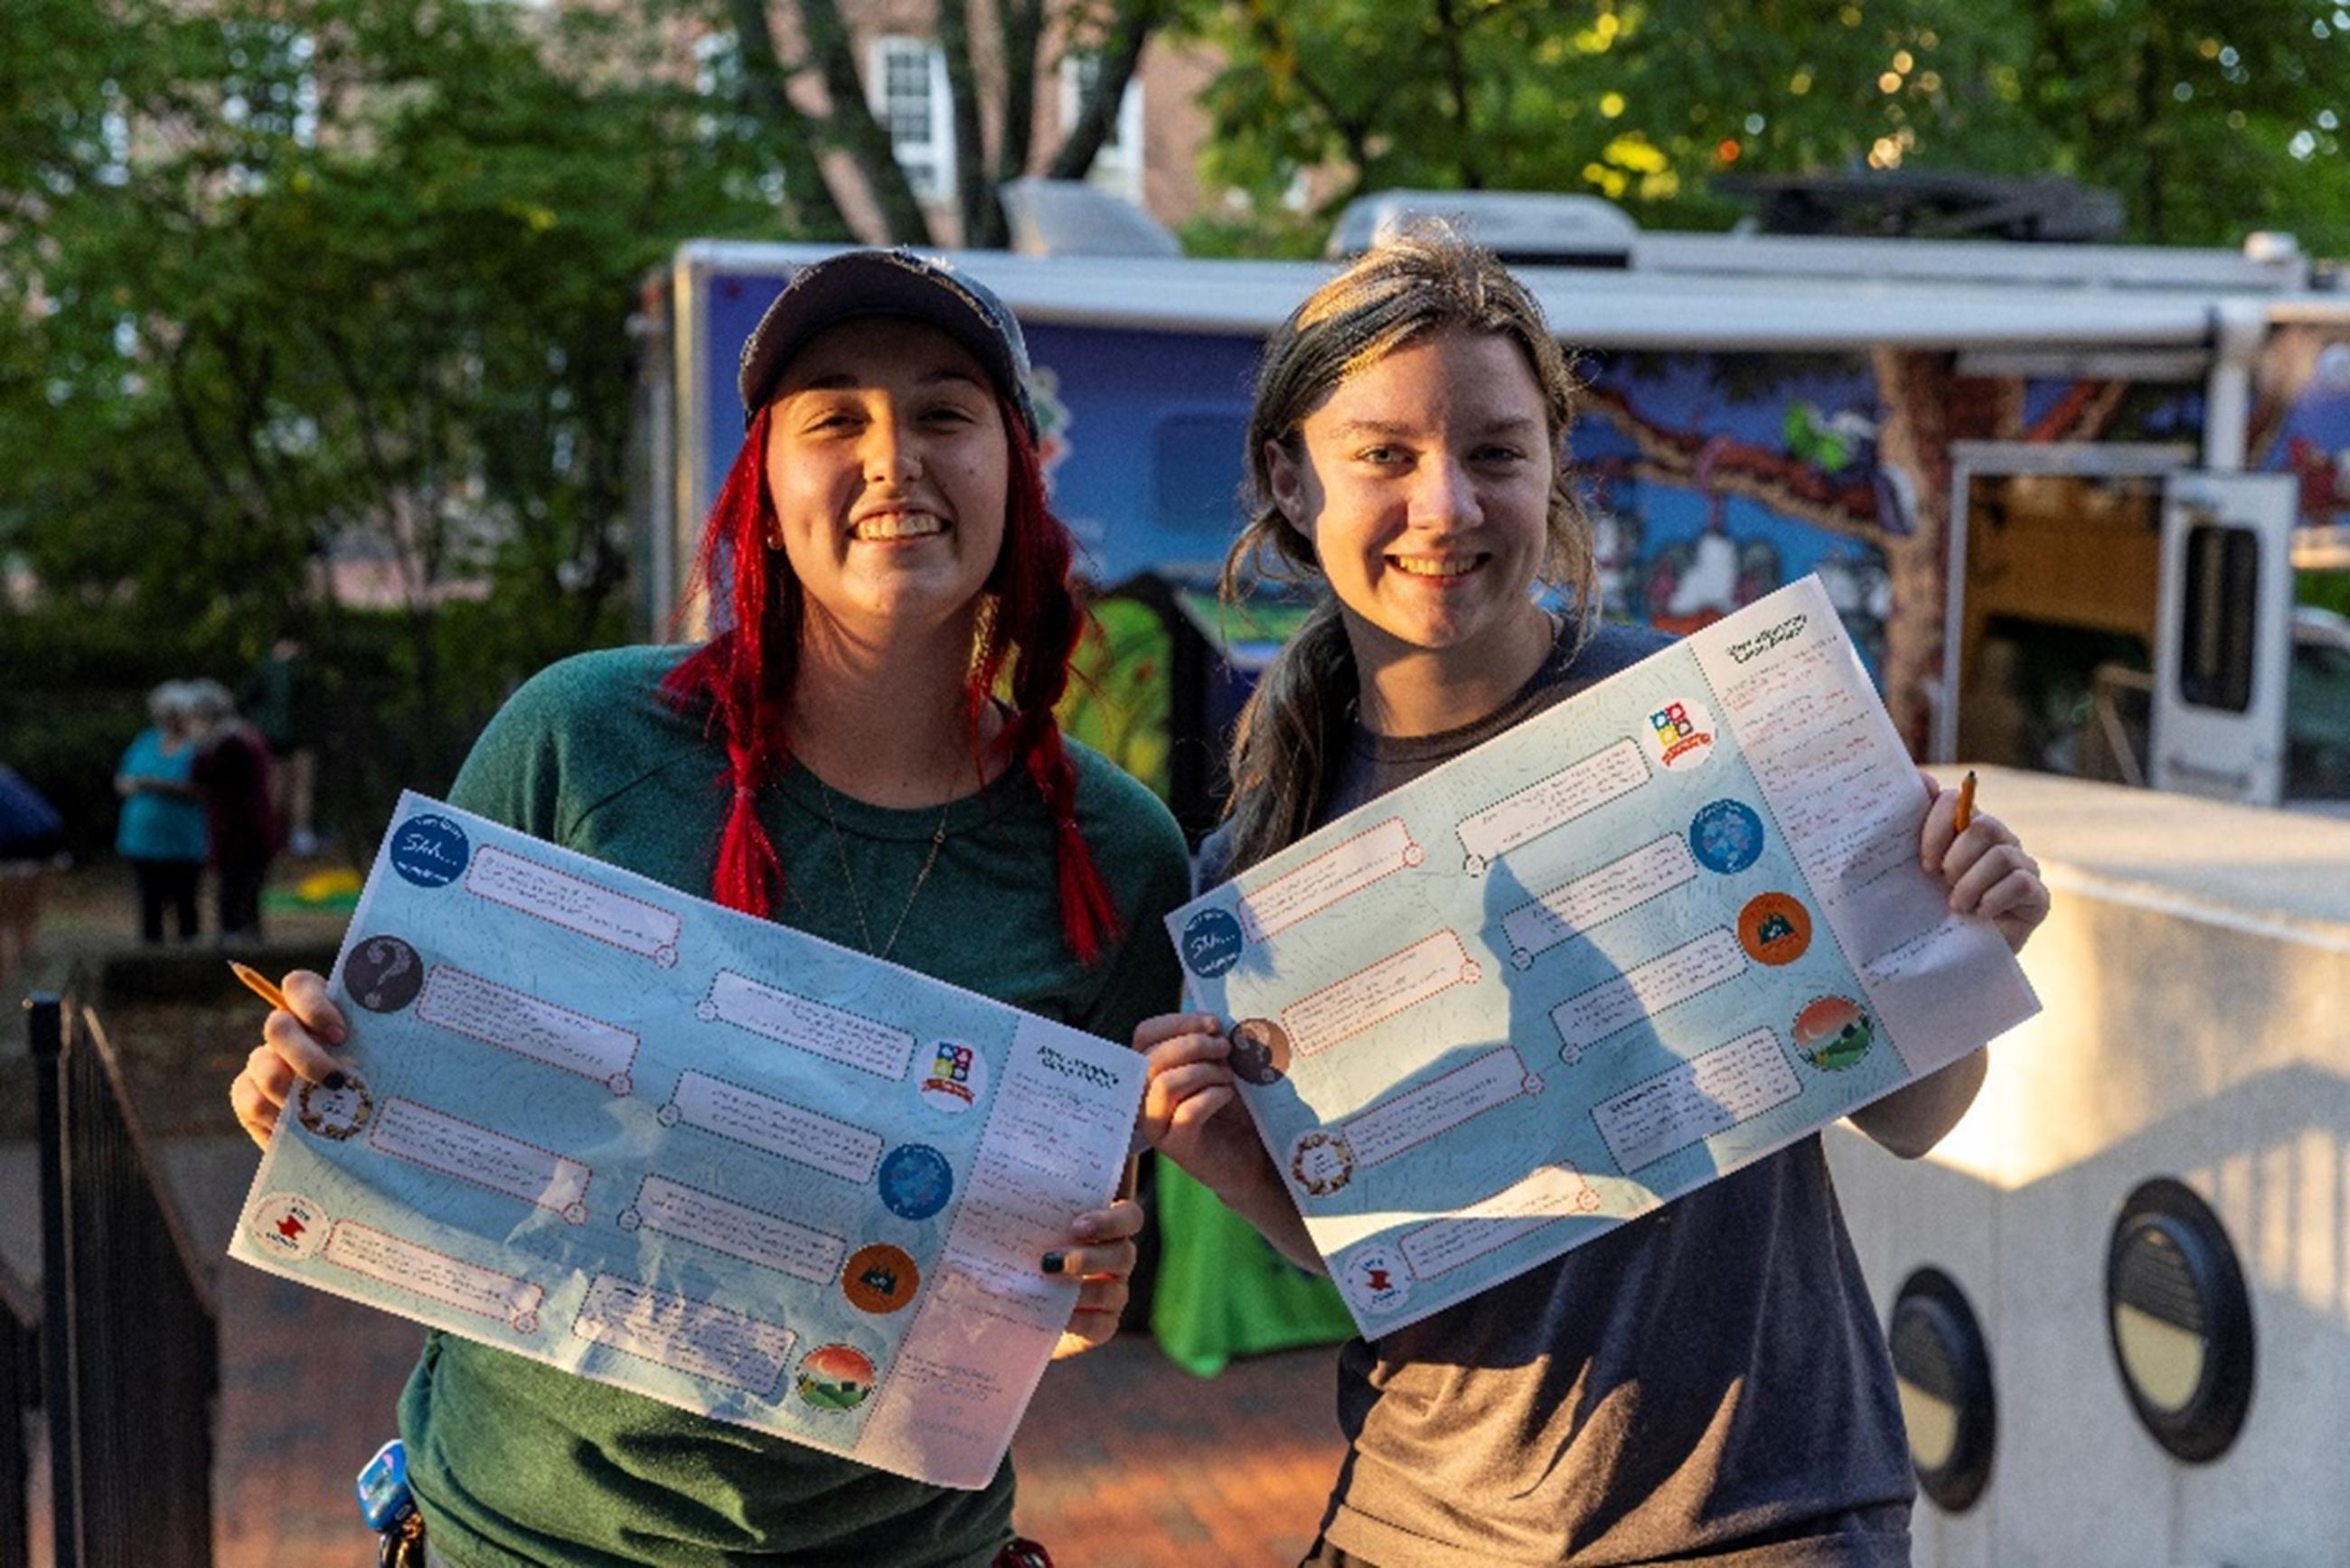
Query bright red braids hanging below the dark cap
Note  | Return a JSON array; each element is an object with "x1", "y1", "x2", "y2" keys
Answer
[{"x1": 661, "y1": 395, "x2": 1119, "y2": 963}]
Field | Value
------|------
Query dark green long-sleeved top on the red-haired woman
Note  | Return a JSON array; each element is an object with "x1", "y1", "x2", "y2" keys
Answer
[{"x1": 400, "y1": 646, "x2": 1189, "y2": 1568}]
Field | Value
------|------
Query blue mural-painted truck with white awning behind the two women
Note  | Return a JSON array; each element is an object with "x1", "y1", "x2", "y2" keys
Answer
[{"x1": 639, "y1": 192, "x2": 2350, "y2": 828}]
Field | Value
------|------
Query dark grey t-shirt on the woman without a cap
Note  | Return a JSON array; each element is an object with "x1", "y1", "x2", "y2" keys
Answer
[{"x1": 1201, "y1": 625, "x2": 1915, "y2": 1568}]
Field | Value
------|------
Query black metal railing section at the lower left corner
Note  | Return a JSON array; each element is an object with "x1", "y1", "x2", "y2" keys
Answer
[{"x1": 26, "y1": 994, "x2": 221, "y2": 1568}]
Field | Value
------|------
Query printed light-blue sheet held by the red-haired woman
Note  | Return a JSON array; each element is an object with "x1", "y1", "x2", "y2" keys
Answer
[{"x1": 228, "y1": 794, "x2": 1142, "y2": 1488}]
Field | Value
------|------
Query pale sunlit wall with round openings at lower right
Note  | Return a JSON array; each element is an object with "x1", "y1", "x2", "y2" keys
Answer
[{"x1": 1828, "y1": 771, "x2": 2350, "y2": 1568}]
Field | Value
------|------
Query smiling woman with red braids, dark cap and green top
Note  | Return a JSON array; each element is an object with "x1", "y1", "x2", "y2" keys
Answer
[{"x1": 232, "y1": 251, "x2": 1189, "y2": 1568}]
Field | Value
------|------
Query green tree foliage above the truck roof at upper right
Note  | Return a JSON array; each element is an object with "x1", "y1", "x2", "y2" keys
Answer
[{"x1": 1196, "y1": 0, "x2": 2350, "y2": 254}]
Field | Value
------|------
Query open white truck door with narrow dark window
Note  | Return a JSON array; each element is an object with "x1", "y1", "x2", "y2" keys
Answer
[{"x1": 2150, "y1": 473, "x2": 2296, "y2": 806}]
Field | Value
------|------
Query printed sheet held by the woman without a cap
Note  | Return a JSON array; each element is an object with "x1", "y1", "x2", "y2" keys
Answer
[{"x1": 1168, "y1": 578, "x2": 2037, "y2": 1338}]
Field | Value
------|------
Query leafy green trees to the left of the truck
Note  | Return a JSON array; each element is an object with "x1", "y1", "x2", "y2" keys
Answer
[{"x1": 0, "y1": 0, "x2": 785, "y2": 832}]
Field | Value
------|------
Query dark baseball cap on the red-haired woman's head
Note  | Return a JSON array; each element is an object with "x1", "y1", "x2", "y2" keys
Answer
[{"x1": 736, "y1": 249, "x2": 1037, "y2": 439}]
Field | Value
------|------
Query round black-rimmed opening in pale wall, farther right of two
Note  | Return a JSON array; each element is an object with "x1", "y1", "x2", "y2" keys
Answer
[{"x1": 2106, "y1": 1178, "x2": 2253, "y2": 1465}]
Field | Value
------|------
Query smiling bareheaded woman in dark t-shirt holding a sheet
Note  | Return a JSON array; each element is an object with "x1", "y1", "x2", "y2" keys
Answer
[{"x1": 1135, "y1": 226, "x2": 2047, "y2": 1568}]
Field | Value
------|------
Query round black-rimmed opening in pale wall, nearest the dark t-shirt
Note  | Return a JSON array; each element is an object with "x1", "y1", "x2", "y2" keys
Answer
[{"x1": 1885, "y1": 1270, "x2": 1998, "y2": 1514}]
